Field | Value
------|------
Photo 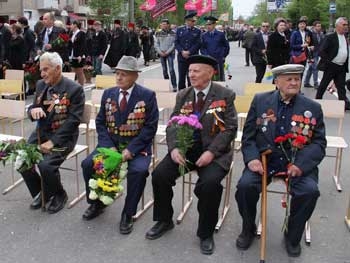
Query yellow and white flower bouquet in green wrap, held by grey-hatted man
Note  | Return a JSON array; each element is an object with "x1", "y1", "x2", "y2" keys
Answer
[{"x1": 89, "y1": 148, "x2": 128, "y2": 205}]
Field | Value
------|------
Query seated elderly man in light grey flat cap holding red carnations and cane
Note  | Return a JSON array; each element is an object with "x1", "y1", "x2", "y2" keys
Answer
[{"x1": 236, "y1": 64, "x2": 326, "y2": 257}]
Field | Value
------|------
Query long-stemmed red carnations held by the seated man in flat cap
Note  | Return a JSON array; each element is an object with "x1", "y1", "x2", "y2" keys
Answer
[{"x1": 275, "y1": 133, "x2": 308, "y2": 232}]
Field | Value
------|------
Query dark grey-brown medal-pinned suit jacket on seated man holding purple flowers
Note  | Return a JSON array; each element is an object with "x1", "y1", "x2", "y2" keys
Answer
[{"x1": 166, "y1": 83, "x2": 237, "y2": 170}]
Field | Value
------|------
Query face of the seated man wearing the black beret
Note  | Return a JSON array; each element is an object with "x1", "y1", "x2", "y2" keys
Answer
[{"x1": 188, "y1": 63, "x2": 214, "y2": 89}]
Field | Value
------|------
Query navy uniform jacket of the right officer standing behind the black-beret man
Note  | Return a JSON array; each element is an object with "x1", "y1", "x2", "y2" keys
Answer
[{"x1": 200, "y1": 29, "x2": 230, "y2": 63}]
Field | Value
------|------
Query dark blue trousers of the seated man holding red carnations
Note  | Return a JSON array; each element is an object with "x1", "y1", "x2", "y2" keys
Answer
[{"x1": 236, "y1": 168, "x2": 320, "y2": 245}]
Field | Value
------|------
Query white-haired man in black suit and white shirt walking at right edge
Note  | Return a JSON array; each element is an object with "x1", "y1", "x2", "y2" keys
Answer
[{"x1": 316, "y1": 17, "x2": 350, "y2": 110}]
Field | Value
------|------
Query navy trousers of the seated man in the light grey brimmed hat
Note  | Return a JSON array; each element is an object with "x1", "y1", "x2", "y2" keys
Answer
[{"x1": 81, "y1": 150, "x2": 151, "y2": 216}]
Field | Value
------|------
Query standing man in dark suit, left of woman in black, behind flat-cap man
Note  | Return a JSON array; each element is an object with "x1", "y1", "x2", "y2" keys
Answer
[{"x1": 252, "y1": 22, "x2": 270, "y2": 83}]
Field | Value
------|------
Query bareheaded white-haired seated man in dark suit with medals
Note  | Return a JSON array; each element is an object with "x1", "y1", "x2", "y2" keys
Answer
[{"x1": 22, "y1": 52, "x2": 85, "y2": 213}]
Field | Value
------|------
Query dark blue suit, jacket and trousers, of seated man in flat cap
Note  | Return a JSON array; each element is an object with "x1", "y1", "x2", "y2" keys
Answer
[{"x1": 236, "y1": 91, "x2": 326, "y2": 245}]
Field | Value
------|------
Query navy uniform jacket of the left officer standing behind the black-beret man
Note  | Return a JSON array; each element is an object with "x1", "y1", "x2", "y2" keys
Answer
[{"x1": 175, "y1": 26, "x2": 201, "y2": 62}]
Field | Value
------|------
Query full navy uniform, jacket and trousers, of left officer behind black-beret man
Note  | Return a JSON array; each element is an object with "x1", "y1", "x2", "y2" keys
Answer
[{"x1": 175, "y1": 26, "x2": 201, "y2": 90}]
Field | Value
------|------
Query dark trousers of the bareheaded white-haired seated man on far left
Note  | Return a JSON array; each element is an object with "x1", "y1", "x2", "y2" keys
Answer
[{"x1": 22, "y1": 152, "x2": 68, "y2": 199}]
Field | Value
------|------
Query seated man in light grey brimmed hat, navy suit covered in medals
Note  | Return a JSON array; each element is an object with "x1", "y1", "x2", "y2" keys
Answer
[{"x1": 82, "y1": 56, "x2": 159, "y2": 234}]
